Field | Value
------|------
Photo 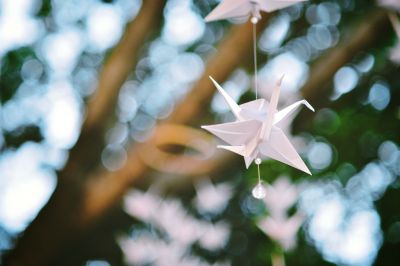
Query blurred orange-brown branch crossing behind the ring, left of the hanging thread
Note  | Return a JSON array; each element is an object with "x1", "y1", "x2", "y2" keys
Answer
[{"x1": 82, "y1": 15, "x2": 269, "y2": 223}]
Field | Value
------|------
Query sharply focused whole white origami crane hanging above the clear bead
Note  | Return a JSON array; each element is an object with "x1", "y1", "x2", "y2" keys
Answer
[{"x1": 202, "y1": 77, "x2": 314, "y2": 175}]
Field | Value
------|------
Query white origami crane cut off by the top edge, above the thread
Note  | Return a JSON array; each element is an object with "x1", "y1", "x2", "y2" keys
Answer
[{"x1": 205, "y1": 0, "x2": 306, "y2": 22}]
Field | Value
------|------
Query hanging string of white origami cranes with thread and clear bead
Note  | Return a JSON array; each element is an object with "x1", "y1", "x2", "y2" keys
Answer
[{"x1": 202, "y1": 0, "x2": 314, "y2": 199}]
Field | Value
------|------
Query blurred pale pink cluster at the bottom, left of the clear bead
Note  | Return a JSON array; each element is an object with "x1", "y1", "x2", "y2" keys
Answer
[{"x1": 119, "y1": 189, "x2": 232, "y2": 266}]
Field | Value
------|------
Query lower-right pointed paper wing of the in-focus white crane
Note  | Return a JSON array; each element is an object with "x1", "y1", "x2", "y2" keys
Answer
[{"x1": 259, "y1": 126, "x2": 311, "y2": 175}]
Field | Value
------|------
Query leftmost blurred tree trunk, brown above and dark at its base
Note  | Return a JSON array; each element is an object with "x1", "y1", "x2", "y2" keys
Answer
[{"x1": 4, "y1": 0, "x2": 165, "y2": 265}]
